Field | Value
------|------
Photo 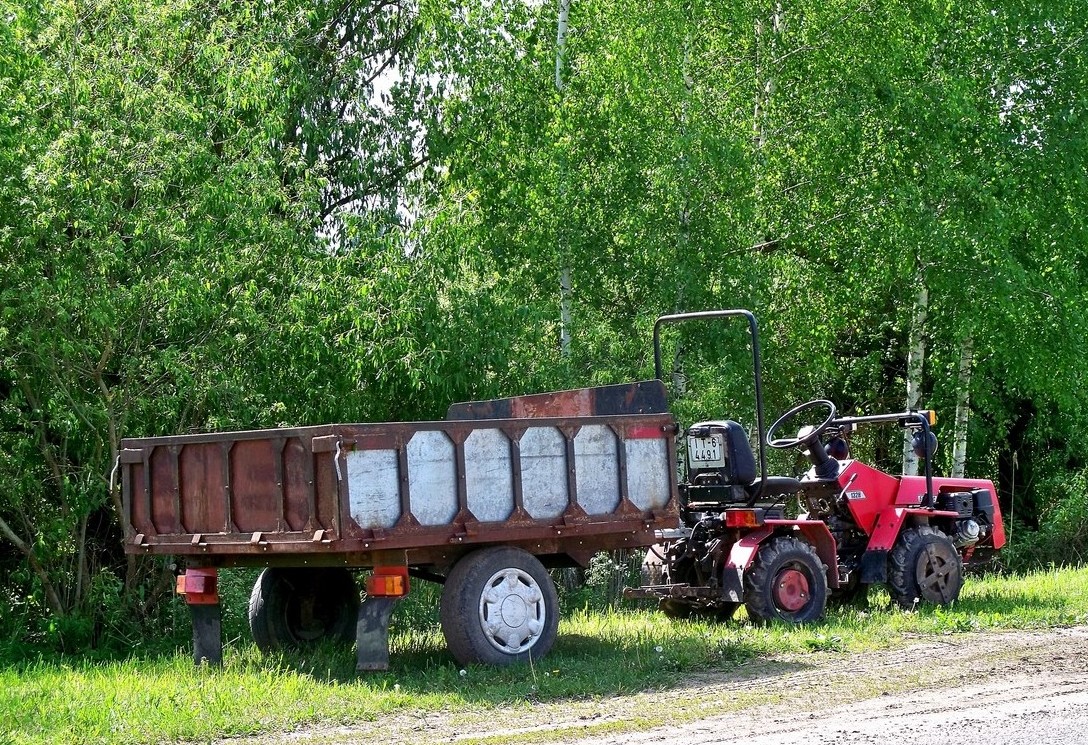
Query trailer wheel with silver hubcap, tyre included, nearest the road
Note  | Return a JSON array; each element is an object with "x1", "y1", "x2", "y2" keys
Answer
[{"x1": 440, "y1": 546, "x2": 559, "y2": 666}]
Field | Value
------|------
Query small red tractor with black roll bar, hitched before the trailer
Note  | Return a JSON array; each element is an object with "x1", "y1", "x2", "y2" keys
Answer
[{"x1": 626, "y1": 310, "x2": 1005, "y2": 623}]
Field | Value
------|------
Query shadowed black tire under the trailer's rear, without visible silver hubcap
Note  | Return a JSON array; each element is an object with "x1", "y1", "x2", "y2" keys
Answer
[{"x1": 249, "y1": 567, "x2": 359, "y2": 653}]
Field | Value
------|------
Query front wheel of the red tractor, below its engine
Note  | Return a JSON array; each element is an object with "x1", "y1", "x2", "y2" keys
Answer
[{"x1": 888, "y1": 525, "x2": 963, "y2": 610}]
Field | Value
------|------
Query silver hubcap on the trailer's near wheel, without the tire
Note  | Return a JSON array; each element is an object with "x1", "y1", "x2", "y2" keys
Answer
[{"x1": 480, "y1": 568, "x2": 547, "y2": 655}]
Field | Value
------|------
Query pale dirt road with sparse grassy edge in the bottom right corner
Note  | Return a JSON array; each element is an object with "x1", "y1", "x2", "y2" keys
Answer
[{"x1": 233, "y1": 626, "x2": 1088, "y2": 745}]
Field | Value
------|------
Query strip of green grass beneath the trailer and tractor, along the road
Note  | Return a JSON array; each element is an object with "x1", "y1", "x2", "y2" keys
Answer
[{"x1": 0, "y1": 570, "x2": 1088, "y2": 745}]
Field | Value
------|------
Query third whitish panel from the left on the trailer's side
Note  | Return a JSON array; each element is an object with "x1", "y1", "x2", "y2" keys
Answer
[{"x1": 465, "y1": 430, "x2": 514, "y2": 522}]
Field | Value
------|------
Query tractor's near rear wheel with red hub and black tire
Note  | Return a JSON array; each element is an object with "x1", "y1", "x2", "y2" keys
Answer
[{"x1": 744, "y1": 536, "x2": 828, "y2": 623}]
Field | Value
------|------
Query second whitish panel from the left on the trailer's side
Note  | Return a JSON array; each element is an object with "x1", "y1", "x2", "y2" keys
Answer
[{"x1": 406, "y1": 430, "x2": 458, "y2": 525}]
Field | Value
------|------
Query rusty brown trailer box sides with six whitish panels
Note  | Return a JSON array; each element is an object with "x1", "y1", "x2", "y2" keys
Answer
[{"x1": 120, "y1": 414, "x2": 677, "y2": 567}]
